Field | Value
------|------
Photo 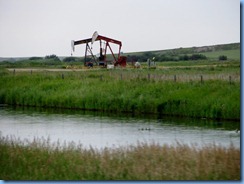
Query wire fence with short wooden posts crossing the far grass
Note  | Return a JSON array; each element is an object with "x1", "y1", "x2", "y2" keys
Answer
[{"x1": 11, "y1": 69, "x2": 240, "y2": 84}]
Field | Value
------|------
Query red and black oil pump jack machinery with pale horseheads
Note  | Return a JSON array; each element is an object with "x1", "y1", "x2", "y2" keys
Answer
[{"x1": 71, "y1": 31, "x2": 126, "y2": 67}]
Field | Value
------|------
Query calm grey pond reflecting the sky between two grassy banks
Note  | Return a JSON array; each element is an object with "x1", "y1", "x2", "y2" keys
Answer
[{"x1": 0, "y1": 107, "x2": 240, "y2": 149}]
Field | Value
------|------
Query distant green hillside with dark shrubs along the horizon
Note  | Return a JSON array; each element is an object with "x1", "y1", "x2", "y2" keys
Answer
[{"x1": 0, "y1": 43, "x2": 240, "y2": 65}]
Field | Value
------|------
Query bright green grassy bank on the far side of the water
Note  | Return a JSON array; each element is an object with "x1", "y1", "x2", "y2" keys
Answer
[{"x1": 0, "y1": 68, "x2": 240, "y2": 120}]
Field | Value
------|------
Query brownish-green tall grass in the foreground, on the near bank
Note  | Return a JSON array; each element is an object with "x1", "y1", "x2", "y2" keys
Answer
[{"x1": 0, "y1": 136, "x2": 240, "y2": 180}]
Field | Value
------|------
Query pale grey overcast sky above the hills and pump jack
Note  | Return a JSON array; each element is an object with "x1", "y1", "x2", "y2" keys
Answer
[{"x1": 0, "y1": 0, "x2": 240, "y2": 57}]
